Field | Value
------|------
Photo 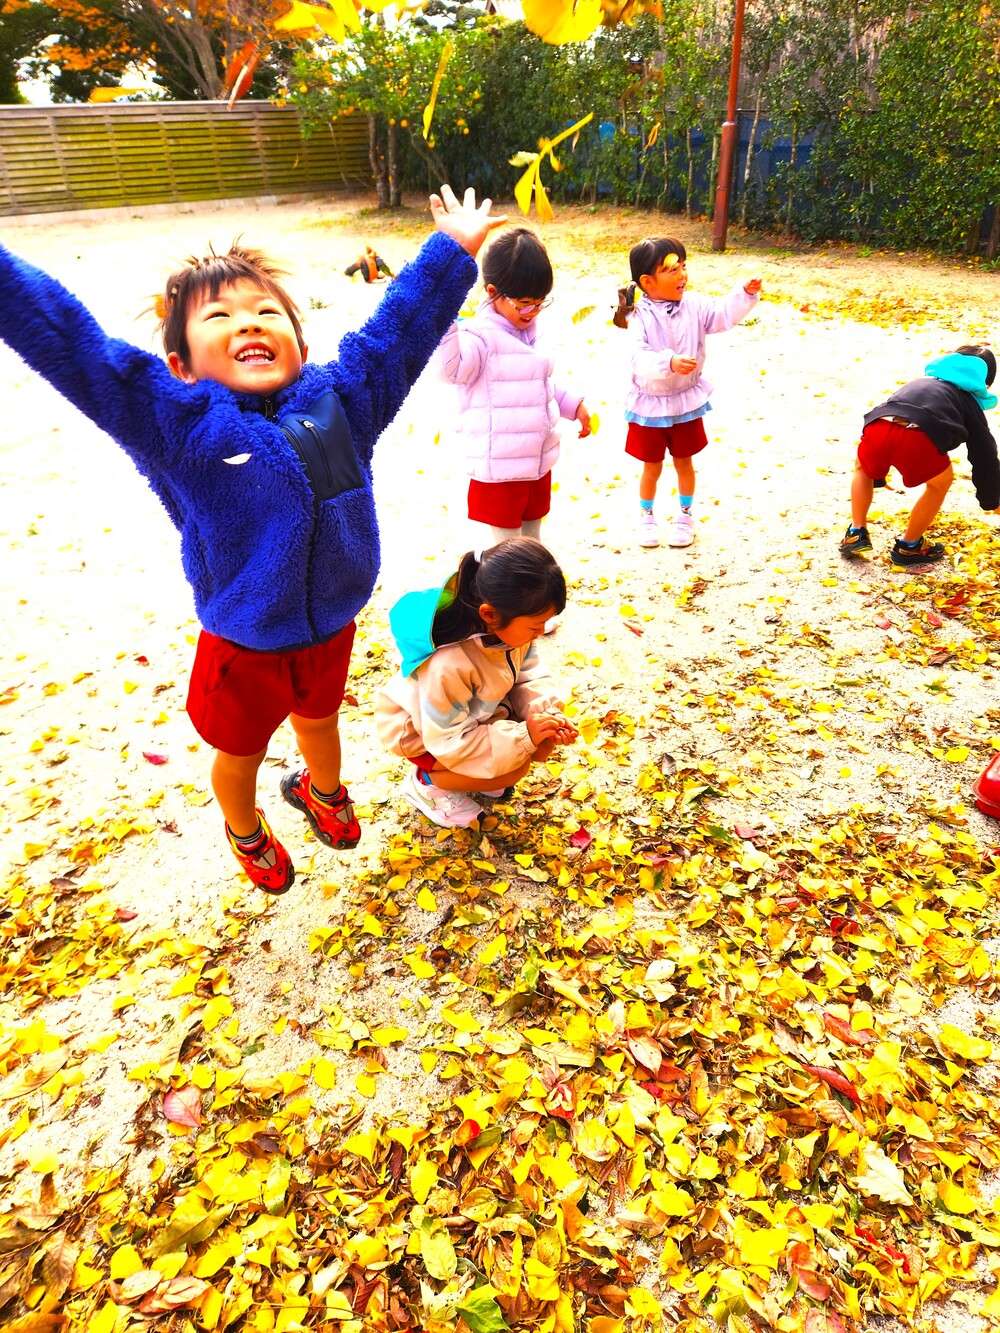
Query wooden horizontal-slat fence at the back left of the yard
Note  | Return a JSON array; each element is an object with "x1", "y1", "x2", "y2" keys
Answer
[{"x1": 0, "y1": 101, "x2": 371, "y2": 215}]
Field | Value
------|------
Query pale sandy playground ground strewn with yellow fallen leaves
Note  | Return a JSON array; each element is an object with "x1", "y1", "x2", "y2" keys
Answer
[{"x1": 0, "y1": 194, "x2": 1000, "y2": 1333}]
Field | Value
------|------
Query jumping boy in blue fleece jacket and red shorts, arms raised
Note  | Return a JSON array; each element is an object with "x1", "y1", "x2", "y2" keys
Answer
[{"x1": 0, "y1": 185, "x2": 504, "y2": 893}]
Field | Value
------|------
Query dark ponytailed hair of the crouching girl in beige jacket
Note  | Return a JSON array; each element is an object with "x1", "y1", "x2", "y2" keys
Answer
[{"x1": 431, "y1": 537, "x2": 565, "y2": 648}]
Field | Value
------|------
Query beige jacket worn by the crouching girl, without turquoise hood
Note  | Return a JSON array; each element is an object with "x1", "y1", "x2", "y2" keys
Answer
[{"x1": 375, "y1": 635, "x2": 563, "y2": 778}]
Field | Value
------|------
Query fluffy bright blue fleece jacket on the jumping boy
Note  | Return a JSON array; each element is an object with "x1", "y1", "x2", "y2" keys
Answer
[{"x1": 0, "y1": 233, "x2": 477, "y2": 652}]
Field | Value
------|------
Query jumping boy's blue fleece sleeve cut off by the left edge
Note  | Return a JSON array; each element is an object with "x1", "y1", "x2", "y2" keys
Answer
[{"x1": 0, "y1": 245, "x2": 184, "y2": 444}]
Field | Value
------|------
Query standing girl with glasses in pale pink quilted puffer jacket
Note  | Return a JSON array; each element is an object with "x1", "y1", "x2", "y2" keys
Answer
[{"x1": 439, "y1": 227, "x2": 591, "y2": 547}]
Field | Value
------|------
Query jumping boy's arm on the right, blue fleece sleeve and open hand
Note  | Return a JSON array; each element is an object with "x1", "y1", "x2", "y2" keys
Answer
[{"x1": 331, "y1": 185, "x2": 505, "y2": 459}]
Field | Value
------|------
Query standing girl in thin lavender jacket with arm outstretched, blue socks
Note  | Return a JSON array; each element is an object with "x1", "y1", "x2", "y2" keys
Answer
[{"x1": 615, "y1": 236, "x2": 761, "y2": 547}]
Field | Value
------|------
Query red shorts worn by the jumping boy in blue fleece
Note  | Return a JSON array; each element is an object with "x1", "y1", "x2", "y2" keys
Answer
[{"x1": 188, "y1": 620, "x2": 355, "y2": 756}]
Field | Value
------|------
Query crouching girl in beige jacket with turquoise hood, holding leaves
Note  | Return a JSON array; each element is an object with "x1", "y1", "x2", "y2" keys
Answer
[{"x1": 375, "y1": 537, "x2": 577, "y2": 828}]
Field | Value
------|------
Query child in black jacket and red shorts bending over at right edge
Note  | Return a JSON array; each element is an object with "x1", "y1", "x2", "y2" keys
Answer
[{"x1": 840, "y1": 344, "x2": 1000, "y2": 568}]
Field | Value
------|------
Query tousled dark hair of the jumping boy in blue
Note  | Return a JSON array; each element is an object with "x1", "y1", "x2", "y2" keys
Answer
[{"x1": 157, "y1": 239, "x2": 305, "y2": 365}]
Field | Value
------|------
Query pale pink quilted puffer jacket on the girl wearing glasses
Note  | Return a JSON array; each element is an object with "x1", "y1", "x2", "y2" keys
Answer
[{"x1": 437, "y1": 303, "x2": 583, "y2": 481}]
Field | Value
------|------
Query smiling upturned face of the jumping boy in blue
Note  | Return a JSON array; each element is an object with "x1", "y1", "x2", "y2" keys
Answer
[{"x1": 167, "y1": 279, "x2": 307, "y2": 397}]
